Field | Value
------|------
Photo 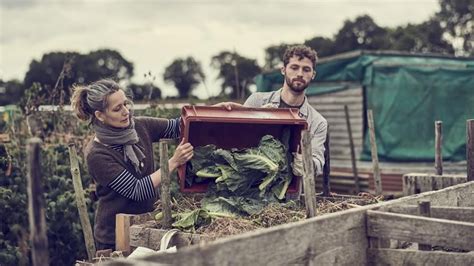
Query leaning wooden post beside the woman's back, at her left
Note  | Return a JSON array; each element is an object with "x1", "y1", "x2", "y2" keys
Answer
[{"x1": 69, "y1": 143, "x2": 96, "y2": 261}]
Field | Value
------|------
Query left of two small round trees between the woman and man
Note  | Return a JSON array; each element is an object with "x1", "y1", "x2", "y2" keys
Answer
[{"x1": 163, "y1": 57, "x2": 205, "y2": 98}]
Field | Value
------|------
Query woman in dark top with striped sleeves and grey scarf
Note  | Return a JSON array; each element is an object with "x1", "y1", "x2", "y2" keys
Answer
[{"x1": 71, "y1": 80, "x2": 193, "y2": 250}]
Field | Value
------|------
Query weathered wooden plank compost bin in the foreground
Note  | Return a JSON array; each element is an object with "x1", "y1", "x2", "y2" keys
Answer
[{"x1": 111, "y1": 181, "x2": 474, "y2": 265}]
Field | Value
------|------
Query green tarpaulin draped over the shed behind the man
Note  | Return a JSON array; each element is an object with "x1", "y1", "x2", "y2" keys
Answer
[{"x1": 256, "y1": 51, "x2": 474, "y2": 161}]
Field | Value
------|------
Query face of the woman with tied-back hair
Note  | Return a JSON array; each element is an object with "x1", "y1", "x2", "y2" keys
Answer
[{"x1": 96, "y1": 90, "x2": 131, "y2": 128}]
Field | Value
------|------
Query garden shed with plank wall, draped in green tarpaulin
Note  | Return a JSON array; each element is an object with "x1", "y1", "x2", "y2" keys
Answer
[{"x1": 256, "y1": 51, "x2": 474, "y2": 192}]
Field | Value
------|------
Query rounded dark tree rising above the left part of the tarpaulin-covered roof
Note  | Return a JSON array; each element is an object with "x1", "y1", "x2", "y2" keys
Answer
[{"x1": 334, "y1": 15, "x2": 390, "y2": 53}]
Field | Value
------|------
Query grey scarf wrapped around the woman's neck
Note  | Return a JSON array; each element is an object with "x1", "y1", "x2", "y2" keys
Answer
[{"x1": 92, "y1": 113, "x2": 145, "y2": 173}]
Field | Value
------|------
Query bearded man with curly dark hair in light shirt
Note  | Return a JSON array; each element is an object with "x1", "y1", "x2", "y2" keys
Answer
[{"x1": 244, "y1": 45, "x2": 327, "y2": 176}]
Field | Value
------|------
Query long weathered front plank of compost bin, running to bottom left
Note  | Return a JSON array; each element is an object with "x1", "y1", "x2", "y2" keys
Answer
[{"x1": 131, "y1": 209, "x2": 368, "y2": 265}]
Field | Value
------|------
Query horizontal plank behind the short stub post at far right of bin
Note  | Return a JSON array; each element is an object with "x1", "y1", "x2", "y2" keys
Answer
[{"x1": 387, "y1": 205, "x2": 474, "y2": 223}]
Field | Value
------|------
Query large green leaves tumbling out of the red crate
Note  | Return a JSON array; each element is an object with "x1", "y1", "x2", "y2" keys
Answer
[{"x1": 157, "y1": 135, "x2": 293, "y2": 230}]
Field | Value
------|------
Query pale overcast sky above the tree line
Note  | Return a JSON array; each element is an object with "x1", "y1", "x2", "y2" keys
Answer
[{"x1": 0, "y1": 0, "x2": 439, "y2": 98}]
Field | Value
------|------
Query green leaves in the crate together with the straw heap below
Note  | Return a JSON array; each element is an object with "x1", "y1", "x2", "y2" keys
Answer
[{"x1": 155, "y1": 134, "x2": 382, "y2": 238}]
